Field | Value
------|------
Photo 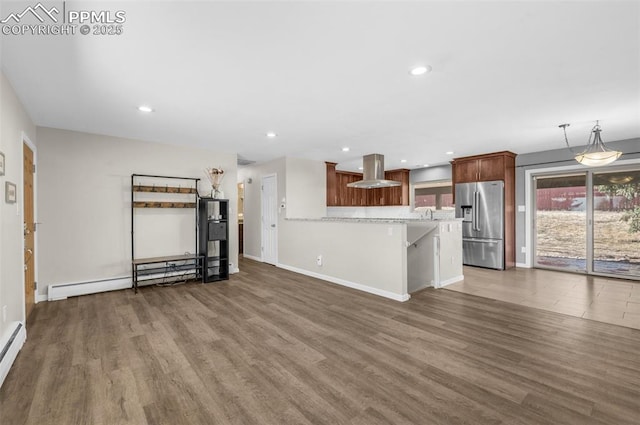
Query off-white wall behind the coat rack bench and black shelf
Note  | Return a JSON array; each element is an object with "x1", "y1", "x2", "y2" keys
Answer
[{"x1": 38, "y1": 127, "x2": 238, "y2": 294}]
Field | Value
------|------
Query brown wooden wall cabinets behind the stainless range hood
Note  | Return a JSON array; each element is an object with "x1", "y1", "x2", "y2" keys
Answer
[{"x1": 325, "y1": 162, "x2": 409, "y2": 207}]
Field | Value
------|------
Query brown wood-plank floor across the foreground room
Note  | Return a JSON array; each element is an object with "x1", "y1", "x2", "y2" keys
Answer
[{"x1": 0, "y1": 260, "x2": 640, "y2": 425}]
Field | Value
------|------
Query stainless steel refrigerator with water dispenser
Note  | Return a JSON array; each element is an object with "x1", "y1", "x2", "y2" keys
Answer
[{"x1": 456, "y1": 180, "x2": 504, "y2": 270}]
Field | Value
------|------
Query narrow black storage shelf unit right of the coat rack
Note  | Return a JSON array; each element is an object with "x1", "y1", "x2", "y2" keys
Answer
[{"x1": 198, "y1": 198, "x2": 229, "y2": 282}]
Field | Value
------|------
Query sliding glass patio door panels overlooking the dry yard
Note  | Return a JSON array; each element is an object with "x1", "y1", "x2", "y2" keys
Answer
[{"x1": 533, "y1": 166, "x2": 640, "y2": 279}]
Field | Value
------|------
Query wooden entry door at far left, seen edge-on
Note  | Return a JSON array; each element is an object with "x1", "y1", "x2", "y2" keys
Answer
[{"x1": 23, "y1": 143, "x2": 36, "y2": 318}]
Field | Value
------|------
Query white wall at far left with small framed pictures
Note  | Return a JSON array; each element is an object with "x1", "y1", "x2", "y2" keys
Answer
[{"x1": 0, "y1": 72, "x2": 36, "y2": 338}]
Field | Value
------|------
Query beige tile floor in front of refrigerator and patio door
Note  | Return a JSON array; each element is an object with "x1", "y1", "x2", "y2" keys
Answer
[{"x1": 446, "y1": 267, "x2": 640, "y2": 329}]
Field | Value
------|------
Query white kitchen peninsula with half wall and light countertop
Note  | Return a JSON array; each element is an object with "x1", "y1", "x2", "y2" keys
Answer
[{"x1": 278, "y1": 217, "x2": 463, "y2": 301}]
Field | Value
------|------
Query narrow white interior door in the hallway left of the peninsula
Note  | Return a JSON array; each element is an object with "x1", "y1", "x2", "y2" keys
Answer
[{"x1": 262, "y1": 175, "x2": 278, "y2": 265}]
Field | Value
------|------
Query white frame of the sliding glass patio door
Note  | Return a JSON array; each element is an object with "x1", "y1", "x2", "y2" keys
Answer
[{"x1": 525, "y1": 159, "x2": 640, "y2": 280}]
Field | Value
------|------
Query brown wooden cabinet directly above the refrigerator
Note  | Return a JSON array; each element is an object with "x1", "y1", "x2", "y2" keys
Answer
[{"x1": 451, "y1": 151, "x2": 516, "y2": 183}]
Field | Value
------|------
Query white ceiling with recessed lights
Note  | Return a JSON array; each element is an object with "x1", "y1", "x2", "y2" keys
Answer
[{"x1": 2, "y1": 1, "x2": 640, "y2": 169}]
